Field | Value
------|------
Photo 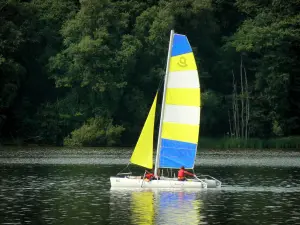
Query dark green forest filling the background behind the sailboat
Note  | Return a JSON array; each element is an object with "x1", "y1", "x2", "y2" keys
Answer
[{"x1": 0, "y1": 0, "x2": 300, "y2": 147}]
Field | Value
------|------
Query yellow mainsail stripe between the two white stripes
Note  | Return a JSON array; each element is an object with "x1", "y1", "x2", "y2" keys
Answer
[{"x1": 166, "y1": 88, "x2": 200, "y2": 106}]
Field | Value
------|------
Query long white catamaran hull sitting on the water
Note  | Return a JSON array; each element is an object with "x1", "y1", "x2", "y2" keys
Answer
[{"x1": 110, "y1": 177, "x2": 221, "y2": 189}]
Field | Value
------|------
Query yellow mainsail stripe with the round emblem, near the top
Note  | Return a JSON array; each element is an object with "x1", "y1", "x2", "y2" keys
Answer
[{"x1": 170, "y1": 52, "x2": 197, "y2": 72}]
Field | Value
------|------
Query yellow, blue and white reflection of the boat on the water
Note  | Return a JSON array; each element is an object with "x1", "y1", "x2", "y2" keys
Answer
[{"x1": 110, "y1": 189, "x2": 202, "y2": 225}]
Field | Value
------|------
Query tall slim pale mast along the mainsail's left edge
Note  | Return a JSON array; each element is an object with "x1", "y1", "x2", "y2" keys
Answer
[{"x1": 154, "y1": 30, "x2": 174, "y2": 176}]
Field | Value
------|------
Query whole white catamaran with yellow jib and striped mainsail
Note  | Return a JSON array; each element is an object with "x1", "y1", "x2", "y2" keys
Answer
[{"x1": 110, "y1": 30, "x2": 221, "y2": 188}]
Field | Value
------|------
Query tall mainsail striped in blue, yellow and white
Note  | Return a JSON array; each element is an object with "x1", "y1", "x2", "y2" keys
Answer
[{"x1": 156, "y1": 34, "x2": 200, "y2": 168}]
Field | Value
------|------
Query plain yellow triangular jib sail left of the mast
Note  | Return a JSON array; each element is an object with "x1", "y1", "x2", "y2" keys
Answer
[{"x1": 130, "y1": 93, "x2": 157, "y2": 169}]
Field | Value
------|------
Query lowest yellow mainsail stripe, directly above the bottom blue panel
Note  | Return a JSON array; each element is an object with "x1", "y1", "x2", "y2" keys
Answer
[{"x1": 162, "y1": 122, "x2": 199, "y2": 144}]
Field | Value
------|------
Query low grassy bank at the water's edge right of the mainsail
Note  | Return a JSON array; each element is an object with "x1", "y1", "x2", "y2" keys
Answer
[{"x1": 198, "y1": 137, "x2": 300, "y2": 150}]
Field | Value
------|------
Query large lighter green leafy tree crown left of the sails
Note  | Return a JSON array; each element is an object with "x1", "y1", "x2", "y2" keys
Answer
[{"x1": 49, "y1": 1, "x2": 128, "y2": 92}]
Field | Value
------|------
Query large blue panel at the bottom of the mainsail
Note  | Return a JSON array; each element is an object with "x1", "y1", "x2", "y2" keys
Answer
[{"x1": 159, "y1": 139, "x2": 197, "y2": 168}]
